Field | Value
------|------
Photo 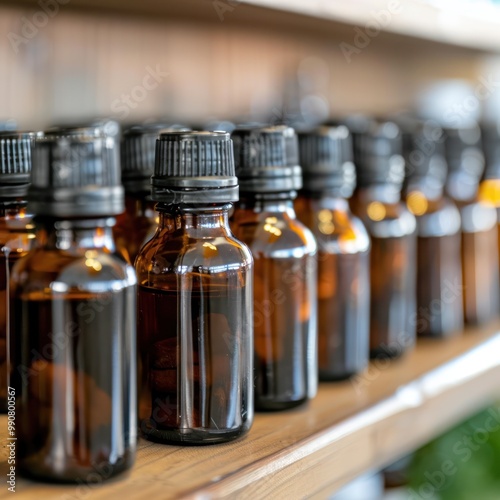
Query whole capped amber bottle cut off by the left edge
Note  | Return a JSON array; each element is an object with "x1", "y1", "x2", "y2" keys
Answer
[{"x1": 0, "y1": 132, "x2": 35, "y2": 411}]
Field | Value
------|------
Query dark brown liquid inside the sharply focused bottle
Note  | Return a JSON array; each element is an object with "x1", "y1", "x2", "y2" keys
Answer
[{"x1": 138, "y1": 285, "x2": 251, "y2": 444}]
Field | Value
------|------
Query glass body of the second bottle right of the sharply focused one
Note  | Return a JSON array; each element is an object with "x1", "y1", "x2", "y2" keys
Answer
[{"x1": 295, "y1": 193, "x2": 370, "y2": 380}]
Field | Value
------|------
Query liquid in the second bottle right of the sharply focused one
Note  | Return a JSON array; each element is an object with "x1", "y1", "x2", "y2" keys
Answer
[{"x1": 318, "y1": 252, "x2": 369, "y2": 380}]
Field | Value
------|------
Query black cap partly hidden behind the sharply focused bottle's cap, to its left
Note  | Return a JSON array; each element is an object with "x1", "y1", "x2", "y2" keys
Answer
[{"x1": 121, "y1": 123, "x2": 189, "y2": 194}]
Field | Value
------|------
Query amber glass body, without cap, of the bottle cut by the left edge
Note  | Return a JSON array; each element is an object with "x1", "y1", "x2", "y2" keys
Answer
[{"x1": 0, "y1": 200, "x2": 35, "y2": 412}]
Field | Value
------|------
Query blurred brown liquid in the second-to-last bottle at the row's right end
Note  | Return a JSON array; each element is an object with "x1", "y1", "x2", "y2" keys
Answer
[{"x1": 417, "y1": 233, "x2": 463, "y2": 337}]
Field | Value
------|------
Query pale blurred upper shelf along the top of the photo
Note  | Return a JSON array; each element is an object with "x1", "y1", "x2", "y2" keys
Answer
[{"x1": 4, "y1": 0, "x2": 500, "y2": 52}]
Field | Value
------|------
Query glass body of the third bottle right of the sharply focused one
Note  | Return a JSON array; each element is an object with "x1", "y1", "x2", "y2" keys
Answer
[{"x1": 351, "y1": 184, "x2": 417, "y2": 357}]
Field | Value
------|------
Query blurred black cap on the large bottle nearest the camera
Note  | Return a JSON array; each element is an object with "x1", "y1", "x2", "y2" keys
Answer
[{"x1": 28, "y1": 127, "x2": 125, "y2": 217}]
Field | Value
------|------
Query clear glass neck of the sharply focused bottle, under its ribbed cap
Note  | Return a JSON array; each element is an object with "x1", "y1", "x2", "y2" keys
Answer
[{"x1": 156, "y1": 203, "x2": 231, "y2": 235}]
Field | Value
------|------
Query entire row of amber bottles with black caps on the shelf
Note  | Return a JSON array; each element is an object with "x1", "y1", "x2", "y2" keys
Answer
[{"x1": 0, "y1": 115, "x2": 499, "y2": 481}]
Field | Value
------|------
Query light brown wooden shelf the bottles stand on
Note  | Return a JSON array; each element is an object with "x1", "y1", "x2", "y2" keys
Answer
[{"x1": 0, "y1": 323, "x2": 500, "y2": 500}]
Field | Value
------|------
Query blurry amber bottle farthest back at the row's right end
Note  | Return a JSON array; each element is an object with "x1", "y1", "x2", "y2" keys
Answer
[{"x1": 445, "y1": 126, "x2": 500, "y2": 325}]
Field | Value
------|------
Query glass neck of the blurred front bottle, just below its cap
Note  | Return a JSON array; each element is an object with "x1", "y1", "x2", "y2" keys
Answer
[{"x1": 35, "y1": 217, "x2": 115, "y2": 252}]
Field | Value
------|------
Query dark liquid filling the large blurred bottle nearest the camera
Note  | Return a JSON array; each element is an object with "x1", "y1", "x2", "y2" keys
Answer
[{"x1": 13, "y1": 288, "x2": 136, "y2": 482}]
